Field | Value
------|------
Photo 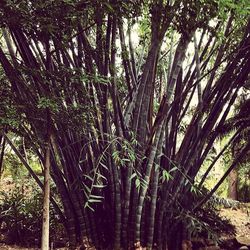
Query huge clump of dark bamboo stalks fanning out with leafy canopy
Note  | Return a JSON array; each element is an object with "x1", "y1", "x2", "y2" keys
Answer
[{"x1": 0, "y1": 0, "x2": 250, "y2": 249}]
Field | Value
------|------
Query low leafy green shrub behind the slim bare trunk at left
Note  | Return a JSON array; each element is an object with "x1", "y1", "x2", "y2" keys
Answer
[{"x1": 0, "y1": 179, "x2": 63, "y2": 246}]
